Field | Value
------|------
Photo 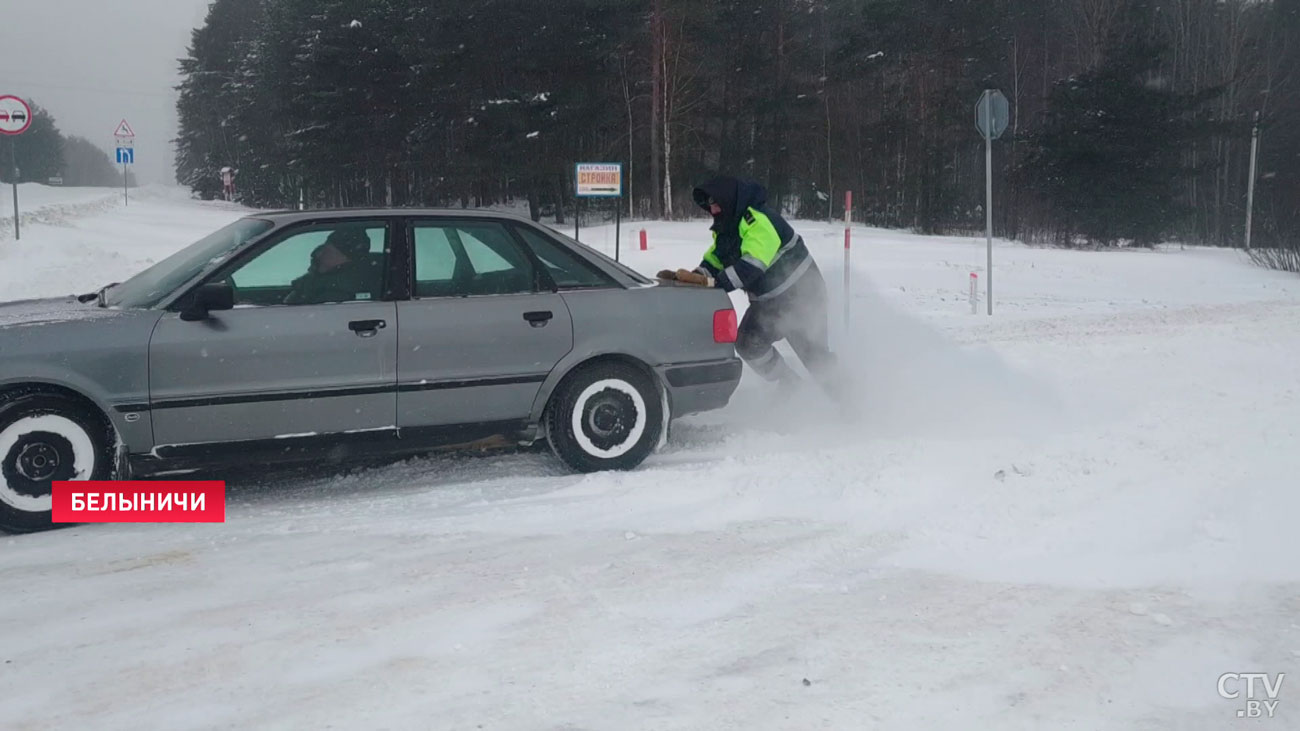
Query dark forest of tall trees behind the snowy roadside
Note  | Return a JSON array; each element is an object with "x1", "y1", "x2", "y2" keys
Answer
[{"x1": 177, "y1": 0, "x2": 1300, "y2": 245}]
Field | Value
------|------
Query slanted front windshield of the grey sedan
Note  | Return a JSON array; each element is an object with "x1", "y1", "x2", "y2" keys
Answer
[{"x1": 104, "y1": 219, "x2": 272, "y2": 308}]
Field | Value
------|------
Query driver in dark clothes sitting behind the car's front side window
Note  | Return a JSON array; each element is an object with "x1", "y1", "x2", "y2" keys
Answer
[{"x1": 285, "y1": 229, "x2": 382, "y2": 304}]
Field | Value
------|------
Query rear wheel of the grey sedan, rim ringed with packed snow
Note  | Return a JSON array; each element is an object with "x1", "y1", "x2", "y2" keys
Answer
[{"x1": 546, "y1": 360, "x2": 664, "y2": 472}]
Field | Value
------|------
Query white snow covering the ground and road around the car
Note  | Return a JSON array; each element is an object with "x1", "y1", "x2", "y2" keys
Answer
[{"x1": 0, "y1": 189, "x2": 1300, "y2": 730}]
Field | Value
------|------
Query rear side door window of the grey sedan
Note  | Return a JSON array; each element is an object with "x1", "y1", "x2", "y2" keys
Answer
[{"x1": 411, "y1": 221, "x2": 536, "y2": 298}]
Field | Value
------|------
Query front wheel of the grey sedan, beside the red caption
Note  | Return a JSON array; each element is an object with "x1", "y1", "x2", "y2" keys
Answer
[{"x1": 0, "y1": 392, "x2": 113, "y2": 532}]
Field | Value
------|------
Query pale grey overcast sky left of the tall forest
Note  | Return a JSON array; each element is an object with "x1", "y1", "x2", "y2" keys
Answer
[{"x1": 0, "y1": 0, "x2": 211, "y2": 182}]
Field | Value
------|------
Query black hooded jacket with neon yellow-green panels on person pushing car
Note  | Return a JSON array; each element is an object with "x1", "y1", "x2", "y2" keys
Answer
[{"x1": 694, "y1": 176, "x2": 813, "y2": 300}]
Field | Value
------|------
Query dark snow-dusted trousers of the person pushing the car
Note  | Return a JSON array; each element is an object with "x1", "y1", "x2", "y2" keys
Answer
[{"x1": 736, "y1": 260, "x2": 835, "y2": 386}]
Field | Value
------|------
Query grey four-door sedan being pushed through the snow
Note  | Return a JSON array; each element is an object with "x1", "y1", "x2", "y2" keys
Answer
[{"x1": 0, "y1": 209, "x2": 741, "y2": 531}]
